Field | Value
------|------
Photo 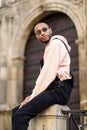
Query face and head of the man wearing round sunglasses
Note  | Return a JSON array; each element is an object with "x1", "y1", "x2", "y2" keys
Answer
[{"x1": 34, "y1": 23, "x2": 52, "y2": 44}]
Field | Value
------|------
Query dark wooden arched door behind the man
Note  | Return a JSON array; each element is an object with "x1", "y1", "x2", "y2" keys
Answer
[{"x1": 23, "y1": 12, "x2": 80, "y2": 109}]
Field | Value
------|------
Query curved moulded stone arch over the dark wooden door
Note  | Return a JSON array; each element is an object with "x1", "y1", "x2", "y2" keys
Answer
[{"x1": 9, "y1": 2, "x2": 83, "y2": 59}]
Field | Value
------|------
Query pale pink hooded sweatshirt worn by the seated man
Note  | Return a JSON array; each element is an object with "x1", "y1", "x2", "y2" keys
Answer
[{"x1": 30, "y1": 35, "x2": 71, "y2": 100}]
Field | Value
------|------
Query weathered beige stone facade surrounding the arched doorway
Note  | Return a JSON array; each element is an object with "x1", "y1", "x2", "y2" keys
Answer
[{"x1": 0, "y1": 0, "x2": 87, "y2": 130}]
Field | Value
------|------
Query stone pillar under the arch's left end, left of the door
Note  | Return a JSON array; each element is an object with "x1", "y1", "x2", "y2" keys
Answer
[{"x1": 7, "y1": 57, "x2": 24, "y2": 108}]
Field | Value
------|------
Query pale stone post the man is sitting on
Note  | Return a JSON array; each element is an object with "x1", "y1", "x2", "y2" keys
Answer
[{"x1": 29, "y1": 105, "x2": 69, "y2": 130}]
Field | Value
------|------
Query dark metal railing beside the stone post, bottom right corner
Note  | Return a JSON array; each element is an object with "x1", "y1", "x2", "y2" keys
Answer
[{"x1": 62, "y1": 110, "x2": 87, "y2": 130}]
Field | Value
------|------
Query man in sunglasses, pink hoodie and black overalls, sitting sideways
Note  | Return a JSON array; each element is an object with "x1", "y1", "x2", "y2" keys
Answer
[{"x1": 12, "y1": 23, "x2": 73, "y2": 130}]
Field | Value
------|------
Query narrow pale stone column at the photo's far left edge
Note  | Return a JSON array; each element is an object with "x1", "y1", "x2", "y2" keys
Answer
[{"x1": 0, "y1": 16, "x2": 7, "y2": 105}]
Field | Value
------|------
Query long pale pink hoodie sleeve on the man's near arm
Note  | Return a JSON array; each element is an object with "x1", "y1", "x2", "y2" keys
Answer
[{"x1": 30, "y1": 41, "x2": 59, "y2": 100}]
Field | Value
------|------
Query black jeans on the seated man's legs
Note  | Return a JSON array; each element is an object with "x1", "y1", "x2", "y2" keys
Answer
[{"x1": 12, "y1": 76, "x2": 71, "y2": 130}]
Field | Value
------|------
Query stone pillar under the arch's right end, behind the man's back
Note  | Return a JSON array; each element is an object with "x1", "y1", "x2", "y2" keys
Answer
[{"x1": 76, "y1": 39, "x2": 87, "y2": 109}]
